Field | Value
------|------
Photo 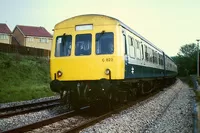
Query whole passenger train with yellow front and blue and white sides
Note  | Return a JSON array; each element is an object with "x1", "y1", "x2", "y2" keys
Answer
[{"x1": 50, "y1": 14, "x2": 177, "y2": 107}]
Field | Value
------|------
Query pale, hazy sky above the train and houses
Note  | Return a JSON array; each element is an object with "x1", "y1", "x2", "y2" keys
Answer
[{"x1": 0, "y1": 0, "x2": 200, "y2": 56}]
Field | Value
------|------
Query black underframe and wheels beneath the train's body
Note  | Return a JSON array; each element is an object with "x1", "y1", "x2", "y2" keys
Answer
[{"x1": 50, "y1": 77, "x2": 176, "y2": 109}]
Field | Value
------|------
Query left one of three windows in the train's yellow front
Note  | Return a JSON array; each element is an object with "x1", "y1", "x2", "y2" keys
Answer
[{"x1": 55, "y1": 35, "x2": 72, "y2": 57}]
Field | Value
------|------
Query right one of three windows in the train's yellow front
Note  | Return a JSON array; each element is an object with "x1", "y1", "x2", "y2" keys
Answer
[{"x1": 96, "y1": 32, "x2": 114, "y2": 55}]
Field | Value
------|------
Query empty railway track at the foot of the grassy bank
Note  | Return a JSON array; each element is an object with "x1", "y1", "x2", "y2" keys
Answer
[{"x1": 0, "y1": 99, "x2": 60, "y2": 119}]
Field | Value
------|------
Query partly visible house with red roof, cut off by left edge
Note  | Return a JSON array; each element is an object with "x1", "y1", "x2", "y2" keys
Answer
[{"x1": 0, "y1": 23, "x2": 12, "y2": 44}]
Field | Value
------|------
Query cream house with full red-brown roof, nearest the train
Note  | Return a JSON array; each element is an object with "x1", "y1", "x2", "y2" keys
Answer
[{"x1": 13, "y1": 25, "x2": 52, "y2": 50}]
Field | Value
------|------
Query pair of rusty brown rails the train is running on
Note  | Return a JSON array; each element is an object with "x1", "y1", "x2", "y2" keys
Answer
[{"x1": 0, "y1": 83, "x2": 175, "y2": 133}]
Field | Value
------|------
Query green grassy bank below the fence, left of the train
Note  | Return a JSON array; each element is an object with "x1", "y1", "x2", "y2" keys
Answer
[{"x1": 0, "y1": 52, "x2": 55, "y2": 103}]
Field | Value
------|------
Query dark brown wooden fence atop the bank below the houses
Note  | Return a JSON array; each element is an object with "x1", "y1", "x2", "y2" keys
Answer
[{"x1": 0, "y1": 43, "x2": 51, "y2": 57}]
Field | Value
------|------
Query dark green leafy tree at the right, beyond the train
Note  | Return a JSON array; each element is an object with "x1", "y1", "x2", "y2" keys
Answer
[{"x1": 172, "y1": 43, "x2": 197, "y2": 76}]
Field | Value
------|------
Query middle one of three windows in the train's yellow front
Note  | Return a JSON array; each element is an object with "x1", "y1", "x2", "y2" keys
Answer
[{"x1": 75, "y1": 34, "x2": 92, "y2": 56}]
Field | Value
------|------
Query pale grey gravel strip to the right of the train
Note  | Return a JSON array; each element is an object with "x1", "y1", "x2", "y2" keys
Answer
[{"x1": 82, "y1": 80, "x2": 194, "y2": 133}]
